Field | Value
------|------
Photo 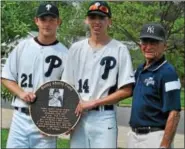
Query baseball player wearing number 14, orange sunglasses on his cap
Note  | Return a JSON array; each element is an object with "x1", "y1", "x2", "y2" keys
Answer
[{"x1": 62, "y1": 1, "x2": 135, "y2": 148}]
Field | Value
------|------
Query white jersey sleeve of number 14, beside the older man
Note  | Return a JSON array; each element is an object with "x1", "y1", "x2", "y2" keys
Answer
[{"x1": 118, "y1": 46, "x2": 135, "y2": 88}]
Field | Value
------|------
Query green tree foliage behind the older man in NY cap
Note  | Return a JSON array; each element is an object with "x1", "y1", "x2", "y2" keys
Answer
[{"x1": 110, "y1": 1, "x2": 185, "y2": 82}]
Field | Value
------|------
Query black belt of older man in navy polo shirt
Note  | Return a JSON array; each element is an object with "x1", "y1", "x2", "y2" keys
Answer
[{"x1": 132, "y1": 126, "x2": 165, "y2": 134}]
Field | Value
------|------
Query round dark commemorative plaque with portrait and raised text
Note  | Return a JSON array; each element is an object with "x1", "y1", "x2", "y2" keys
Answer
[{"x1": 30, "y1": 81, "x2": 80, "y2": 136}]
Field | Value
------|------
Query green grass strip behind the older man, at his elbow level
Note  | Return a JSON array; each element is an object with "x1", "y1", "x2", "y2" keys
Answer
[{"x1": 118, "y1": 89, "x2": 185, "y2": 109}]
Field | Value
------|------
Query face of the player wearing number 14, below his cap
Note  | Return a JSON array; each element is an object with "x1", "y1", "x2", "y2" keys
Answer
[{"x1": 87, "y1": 15, "x2": 111, "y2": 35}]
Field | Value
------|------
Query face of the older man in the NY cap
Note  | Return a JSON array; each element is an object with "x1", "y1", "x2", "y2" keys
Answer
[{"x1": 141, "y1": 38, "x2": 166, "y2": 61}]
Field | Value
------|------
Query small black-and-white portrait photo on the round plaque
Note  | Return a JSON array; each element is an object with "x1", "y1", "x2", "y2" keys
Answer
[{"x1": 48, "y1": 88, "x2": 64, "y2": 107}]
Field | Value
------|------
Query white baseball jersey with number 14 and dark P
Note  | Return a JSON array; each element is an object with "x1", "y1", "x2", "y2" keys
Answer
[{"x1": 62, "y1": 39, "x2": 135, "y2": 101}]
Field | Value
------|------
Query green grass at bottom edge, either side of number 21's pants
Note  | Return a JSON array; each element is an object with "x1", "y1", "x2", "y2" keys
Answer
[{"x1": 1, "y1": 129, "x2": 69, "y2": 148}]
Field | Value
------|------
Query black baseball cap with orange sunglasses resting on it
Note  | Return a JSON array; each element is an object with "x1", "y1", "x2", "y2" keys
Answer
[{"x1": 87, "y1": 1, "x2": 112, "y2": 18}]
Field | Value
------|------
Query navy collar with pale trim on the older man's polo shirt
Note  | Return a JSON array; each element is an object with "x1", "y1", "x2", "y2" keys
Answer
[{"x1": 142, "y1": 55, "x2": 167, "y2": 71}]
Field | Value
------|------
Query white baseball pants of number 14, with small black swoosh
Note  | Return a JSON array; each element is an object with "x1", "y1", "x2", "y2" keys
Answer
[{"x1": 70, "y1": 111, "x2": 118, "y2": 148}]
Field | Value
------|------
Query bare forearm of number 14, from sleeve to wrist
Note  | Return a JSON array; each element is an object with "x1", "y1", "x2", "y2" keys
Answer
[{"x1": 95, "y1": 84, "x2": 132, "y2": 106}]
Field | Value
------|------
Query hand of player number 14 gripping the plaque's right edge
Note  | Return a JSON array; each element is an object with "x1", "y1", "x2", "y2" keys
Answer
[{"x1": 75, "y1": 100, "x2": 96, "y2": 116}]
